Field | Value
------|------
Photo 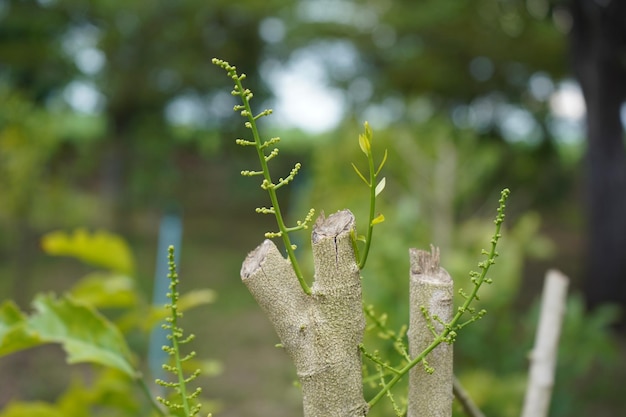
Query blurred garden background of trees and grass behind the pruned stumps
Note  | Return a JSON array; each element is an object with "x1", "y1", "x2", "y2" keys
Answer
[{"x1": 0, "y1": 0, "x2": 626, "y2": 417}]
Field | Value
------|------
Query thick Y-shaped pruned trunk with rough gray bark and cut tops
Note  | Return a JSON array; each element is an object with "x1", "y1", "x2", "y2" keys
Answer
[{"x1": 241, "y1": 210, "x2": 368, "y2": 417}]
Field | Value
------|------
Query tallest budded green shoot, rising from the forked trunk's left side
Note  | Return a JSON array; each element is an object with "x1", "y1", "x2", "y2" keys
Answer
[{"x1": 212, "y1": 58, "x2": 315, "y2": 294}]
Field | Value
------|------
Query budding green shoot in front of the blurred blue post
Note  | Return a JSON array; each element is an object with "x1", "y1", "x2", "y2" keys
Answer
[{"x1": 156, "y1": 246, "x2": 202, "y2": 417}]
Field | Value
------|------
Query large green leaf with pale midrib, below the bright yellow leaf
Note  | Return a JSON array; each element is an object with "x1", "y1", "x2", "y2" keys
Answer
[{"x1": 27, "y1": 295, "x2": 136, "y2": 378}]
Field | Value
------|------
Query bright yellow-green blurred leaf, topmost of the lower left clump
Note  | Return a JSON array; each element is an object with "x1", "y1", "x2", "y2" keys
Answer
[{"x1": 41, "y1": 229, "x2": 135, "y2": 276}]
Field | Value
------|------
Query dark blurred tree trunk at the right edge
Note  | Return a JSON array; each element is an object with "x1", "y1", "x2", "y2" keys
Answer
[{"x1": 570, "y1": 0, "x2": 626, "y2": 322}]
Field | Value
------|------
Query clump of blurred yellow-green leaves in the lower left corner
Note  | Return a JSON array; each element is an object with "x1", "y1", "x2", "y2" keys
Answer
[{"x1": 0, "y1": 229, "x2": 219, "y2": 417}]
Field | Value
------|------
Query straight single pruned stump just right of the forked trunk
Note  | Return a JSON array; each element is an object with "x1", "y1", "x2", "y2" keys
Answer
[{"x1": 407, "y1": 248, "x2": 454, "y2": 417}]
